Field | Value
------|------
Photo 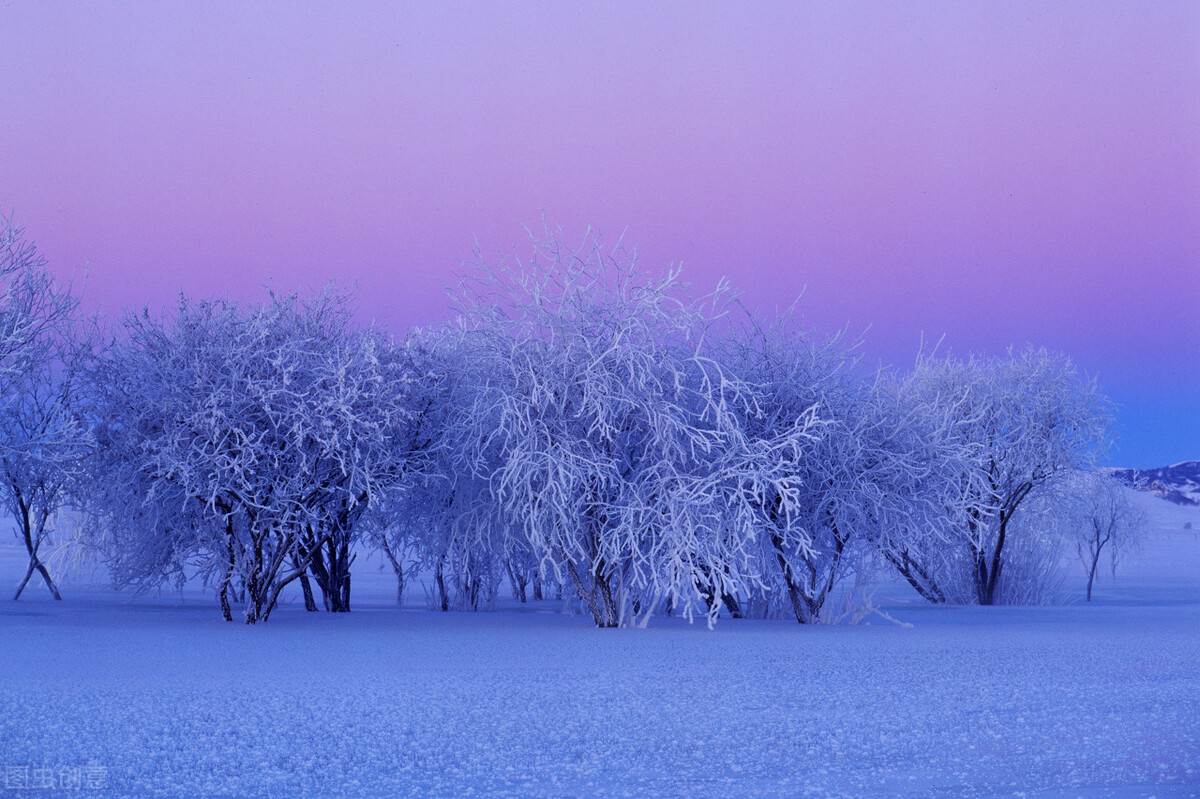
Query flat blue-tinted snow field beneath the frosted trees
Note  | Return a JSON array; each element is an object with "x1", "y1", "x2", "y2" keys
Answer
[{"x1": 0, "y1": 489, "x2": 1200, "y2": 798}]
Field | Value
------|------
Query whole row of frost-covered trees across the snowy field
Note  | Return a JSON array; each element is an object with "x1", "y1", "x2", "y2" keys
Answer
[{"x1": 0, "y1": 215, "x2": 1129, "y2": 627}]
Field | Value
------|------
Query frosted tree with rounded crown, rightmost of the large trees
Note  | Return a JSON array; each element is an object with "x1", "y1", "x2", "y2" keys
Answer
[{"x1": 910, "y1": 349, "x2": 1108, "y2": 605}]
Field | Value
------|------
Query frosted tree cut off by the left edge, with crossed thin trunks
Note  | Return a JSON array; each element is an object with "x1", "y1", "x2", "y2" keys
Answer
[{"x1": 0, "y1": 220, "x2": 89, "y2": 600}]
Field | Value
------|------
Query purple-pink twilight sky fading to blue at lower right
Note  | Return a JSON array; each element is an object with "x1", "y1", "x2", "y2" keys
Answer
[{"x1": 0, "y1": 0, "x2": 1200, "y2": 465}]
